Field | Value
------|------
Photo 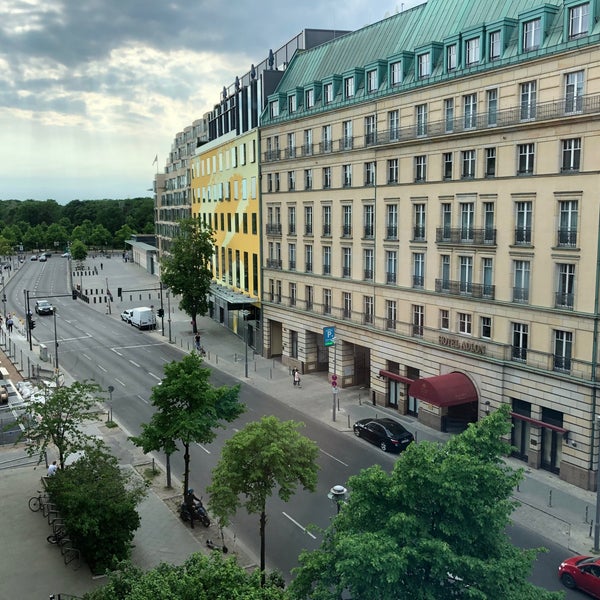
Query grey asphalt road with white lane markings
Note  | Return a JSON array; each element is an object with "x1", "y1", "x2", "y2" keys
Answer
[{"x1": 7, "y1": 257, "x2": 586, "y2": 599}]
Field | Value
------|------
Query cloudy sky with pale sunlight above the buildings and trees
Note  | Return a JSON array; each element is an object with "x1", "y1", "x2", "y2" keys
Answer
[{"x1": 0, "y1": 0, "x2": 424, "y2": 203}]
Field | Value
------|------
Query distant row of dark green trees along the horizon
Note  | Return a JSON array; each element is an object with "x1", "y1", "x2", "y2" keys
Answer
[{"x1": 0, "y1": 198, "x2": 154, "y2": 255}]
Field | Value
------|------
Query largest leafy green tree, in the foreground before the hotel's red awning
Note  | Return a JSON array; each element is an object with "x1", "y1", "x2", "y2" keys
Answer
[{"x1": 290, "y1": 405, "x2": 563, "y2": 600}]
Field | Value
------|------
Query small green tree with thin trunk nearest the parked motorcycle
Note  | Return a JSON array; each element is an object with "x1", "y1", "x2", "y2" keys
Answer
[{"x1": 131, "y1": 352, "x2": 245, "y2": 492}]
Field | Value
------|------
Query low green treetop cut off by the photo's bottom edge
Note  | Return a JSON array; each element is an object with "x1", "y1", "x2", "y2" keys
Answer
[{"x1": 83, "y1": 552, "x2": 287, "y2": 600}]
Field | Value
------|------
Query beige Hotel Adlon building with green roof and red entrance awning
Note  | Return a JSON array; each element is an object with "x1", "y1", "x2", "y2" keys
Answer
[{"x1": 261, "y1": 0, "x2": 600, "y2": 489}]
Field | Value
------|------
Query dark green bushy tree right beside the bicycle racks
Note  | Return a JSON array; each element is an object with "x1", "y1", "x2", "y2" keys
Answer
[{"x1": 47, "y1": 440, "x2": 146, "y2": 574}]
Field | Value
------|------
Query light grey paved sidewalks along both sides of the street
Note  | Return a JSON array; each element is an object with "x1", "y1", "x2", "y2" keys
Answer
[{"x1": 0, "y1": 256, "x2": 596, "y2": 600}]
